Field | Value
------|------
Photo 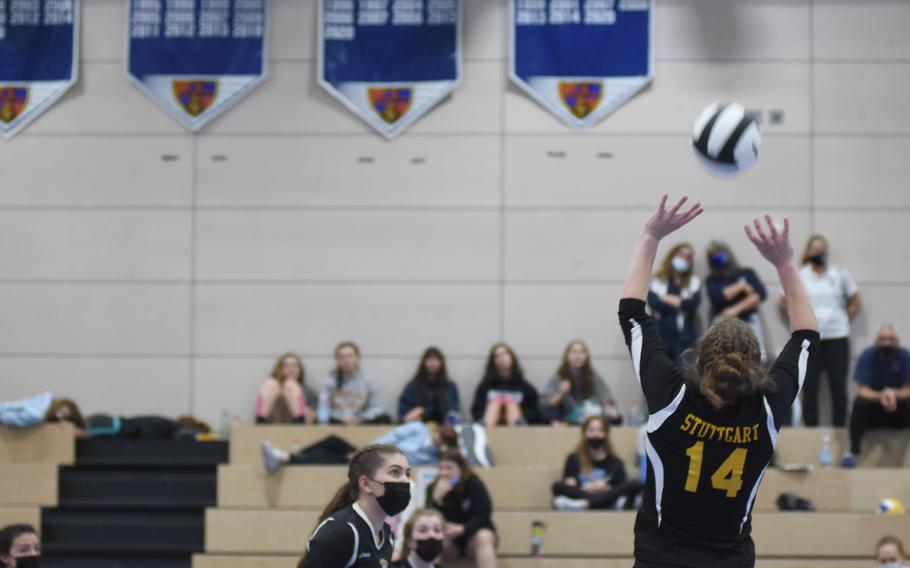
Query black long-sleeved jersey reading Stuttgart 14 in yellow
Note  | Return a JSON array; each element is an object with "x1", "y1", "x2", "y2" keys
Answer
[{"x1": 619, "y1": 298, "x2": 819, "y2": 568}]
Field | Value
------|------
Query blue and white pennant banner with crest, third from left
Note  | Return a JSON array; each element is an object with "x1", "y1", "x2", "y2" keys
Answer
[{"x1": 319, "y1": 0, "x2": 461, "y2": 138}]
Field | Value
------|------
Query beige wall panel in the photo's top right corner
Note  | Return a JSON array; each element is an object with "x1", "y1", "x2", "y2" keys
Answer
[{"x1": 812, "y1": 0, "x2": 910, "y2": 60}]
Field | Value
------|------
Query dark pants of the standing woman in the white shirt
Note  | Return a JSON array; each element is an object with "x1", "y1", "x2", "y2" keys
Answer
[{"x1": 803, "y1": 337, "x2": 850, "y2": 426}]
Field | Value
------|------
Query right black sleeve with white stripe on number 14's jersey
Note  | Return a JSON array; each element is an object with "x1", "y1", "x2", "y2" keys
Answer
[{"x1": 767, "y1": 330, "x2": 819, "y2": 429}]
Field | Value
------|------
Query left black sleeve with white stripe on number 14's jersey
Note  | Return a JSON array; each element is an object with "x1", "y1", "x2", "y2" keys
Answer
[{"x1": 619, "y1": 298, "x2": 684, "y2": 414}]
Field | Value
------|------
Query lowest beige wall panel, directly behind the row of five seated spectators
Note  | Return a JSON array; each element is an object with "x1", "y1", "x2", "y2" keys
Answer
[{"x1": 193, "y1": 358, "x2": 486, "y2": 426}]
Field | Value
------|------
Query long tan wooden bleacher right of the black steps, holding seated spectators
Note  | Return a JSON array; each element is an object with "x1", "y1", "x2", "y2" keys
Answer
[{"x1": 193, "y1": 426, "x2": 910, "y2": 568}]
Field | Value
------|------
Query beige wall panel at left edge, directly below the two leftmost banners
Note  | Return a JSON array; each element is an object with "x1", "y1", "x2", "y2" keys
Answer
[{"x1": 0, "y1": 136, "x2": 193, "y2": 207}]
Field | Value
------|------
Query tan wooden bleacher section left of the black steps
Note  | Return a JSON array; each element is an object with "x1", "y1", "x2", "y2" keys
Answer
[{"x1": 0, "y1": 424, "x2": 76, "y2": 527}]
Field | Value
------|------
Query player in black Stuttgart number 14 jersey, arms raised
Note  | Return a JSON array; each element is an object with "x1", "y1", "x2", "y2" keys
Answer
[{"x1": 619, "y1": 195, "x2": 819, "y2": 568}]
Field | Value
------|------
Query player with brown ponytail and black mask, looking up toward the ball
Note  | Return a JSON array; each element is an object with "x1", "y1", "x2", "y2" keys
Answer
[{"x1": 298, "y1": 445, "x2": 411, "y2": 568}]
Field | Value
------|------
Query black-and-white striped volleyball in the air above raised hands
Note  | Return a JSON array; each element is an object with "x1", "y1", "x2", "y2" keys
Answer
[{"x1": 692, "y1": 103, "x2": 761, "y2": 173}]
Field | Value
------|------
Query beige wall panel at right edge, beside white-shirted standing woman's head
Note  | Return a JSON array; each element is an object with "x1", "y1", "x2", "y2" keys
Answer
[{"x1": 816, "y1": 211, "x2": 910, "y2": 284}]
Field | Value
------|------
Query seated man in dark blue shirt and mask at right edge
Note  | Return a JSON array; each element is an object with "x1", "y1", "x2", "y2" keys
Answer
[{"x1": 841, "y1": 325, "x2": 910, "y2": 467}]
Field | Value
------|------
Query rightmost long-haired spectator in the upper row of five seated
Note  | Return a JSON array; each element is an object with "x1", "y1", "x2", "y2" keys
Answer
[{"x1": 542, "y1": 340, "x2": 622, "y2": 424}]
